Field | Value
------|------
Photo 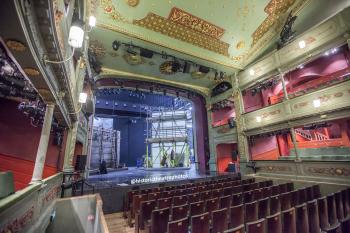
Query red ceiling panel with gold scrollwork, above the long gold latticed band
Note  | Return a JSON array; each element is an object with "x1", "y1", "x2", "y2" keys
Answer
[{"x1": 168, "y1": 7, "x2": 225, "y2": 39}]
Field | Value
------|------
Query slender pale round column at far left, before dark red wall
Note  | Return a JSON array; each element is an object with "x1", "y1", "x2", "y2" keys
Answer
[{"x1": 32, "y1": 103, "x2": 55, "y2": 182}]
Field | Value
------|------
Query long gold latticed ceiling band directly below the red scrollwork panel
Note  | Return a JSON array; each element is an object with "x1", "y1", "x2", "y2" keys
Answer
[{"x1": 133, "y1": 13, "x2": 230, "y2": 56}]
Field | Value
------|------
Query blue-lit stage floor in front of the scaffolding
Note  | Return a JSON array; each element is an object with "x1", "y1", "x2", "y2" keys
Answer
[{"x1": 88, "y1": 167, "x2": 218, "y2": 186}]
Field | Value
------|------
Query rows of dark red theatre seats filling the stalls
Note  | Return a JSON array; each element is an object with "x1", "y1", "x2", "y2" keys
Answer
[{"x1": 121, "y1": 177, "x2": 350, "y2": 233}]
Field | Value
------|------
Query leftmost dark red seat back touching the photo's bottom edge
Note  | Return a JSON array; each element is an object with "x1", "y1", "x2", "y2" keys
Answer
[{"x1": 151, "y1": 208, "x2": 170, "y2": 233}]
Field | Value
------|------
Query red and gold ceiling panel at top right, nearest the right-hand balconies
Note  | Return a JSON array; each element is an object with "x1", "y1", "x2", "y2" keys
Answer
[{"x1": 252, "y1": 0, "x2": 296, "y2": 45}]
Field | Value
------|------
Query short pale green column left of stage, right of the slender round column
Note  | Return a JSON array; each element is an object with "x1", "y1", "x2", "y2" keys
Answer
[{"x1": 63, "y1": 121, "x2": 79, "y2": 172}]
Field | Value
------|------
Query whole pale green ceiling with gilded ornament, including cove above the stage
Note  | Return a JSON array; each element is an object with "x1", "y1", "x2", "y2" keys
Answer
[{"x1": 88, "y1": 0, "x2": 330, "y2": 93}]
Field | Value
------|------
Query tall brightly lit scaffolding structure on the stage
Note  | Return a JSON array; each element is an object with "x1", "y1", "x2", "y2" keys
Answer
[{"x1": 144, "y1": 108, "x2": 192, "y2": 168}]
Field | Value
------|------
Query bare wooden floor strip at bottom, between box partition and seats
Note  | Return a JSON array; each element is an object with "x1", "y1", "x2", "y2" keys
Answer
[{"x1": 105, "y1": 212, "x2": 135, "y2": 233}]
